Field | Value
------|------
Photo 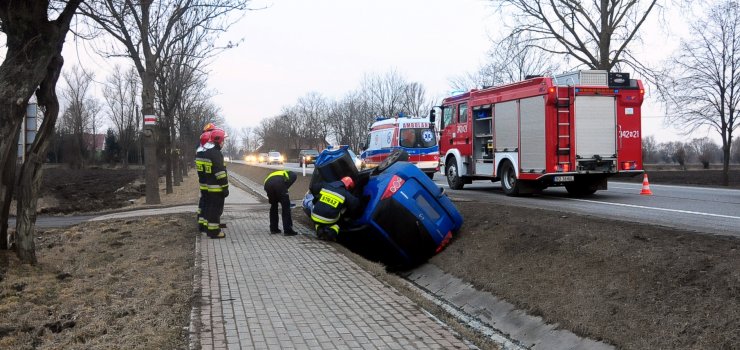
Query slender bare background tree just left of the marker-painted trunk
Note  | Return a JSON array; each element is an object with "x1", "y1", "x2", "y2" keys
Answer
[{"x1": 103, "y1": 66, "x2": 139, "y2": 168}]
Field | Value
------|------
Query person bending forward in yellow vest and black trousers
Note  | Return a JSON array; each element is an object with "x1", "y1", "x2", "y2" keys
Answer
[{"x1": 265, "y1": 170, "x2": 298, "y2": 236}]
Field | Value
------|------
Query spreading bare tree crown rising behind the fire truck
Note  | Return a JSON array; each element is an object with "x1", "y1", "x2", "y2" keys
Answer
[{"x1": 490, "y1": 0, "x2": 661, "y2": 74}]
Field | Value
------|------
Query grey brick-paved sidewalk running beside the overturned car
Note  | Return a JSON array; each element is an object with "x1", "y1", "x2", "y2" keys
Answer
[{"x1": 194, "y1": 206, "x2": 472, "y2": 349}]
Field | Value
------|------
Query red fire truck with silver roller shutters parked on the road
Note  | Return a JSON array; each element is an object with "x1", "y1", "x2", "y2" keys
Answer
[{"x1": 430, "y1": 71, "x2": 645, "y2": 196}]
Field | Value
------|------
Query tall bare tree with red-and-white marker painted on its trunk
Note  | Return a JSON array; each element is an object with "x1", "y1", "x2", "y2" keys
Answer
[{"x1": 80, "y1": 0, "x2": 249, "y2": 204}]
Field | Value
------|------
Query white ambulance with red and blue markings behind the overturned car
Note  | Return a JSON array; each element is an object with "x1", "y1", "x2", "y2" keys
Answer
[{"x1": 360, "y1": 115, "x2": 439, "y2": 178}]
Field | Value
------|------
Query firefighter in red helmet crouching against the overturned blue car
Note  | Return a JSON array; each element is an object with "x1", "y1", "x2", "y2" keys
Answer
[{"x1": 311, "y1": 176, "x2": 360, "y2": 241}]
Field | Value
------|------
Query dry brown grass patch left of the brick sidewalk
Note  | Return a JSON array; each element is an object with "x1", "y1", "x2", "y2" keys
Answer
[{"x1": 0, "y1": 215, "x2": 196, "y2": 349}]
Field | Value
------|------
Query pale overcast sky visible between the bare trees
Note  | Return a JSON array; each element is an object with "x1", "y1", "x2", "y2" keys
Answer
[{"x1": 50, "y1": 0, "x2": 706, "y2": 141}]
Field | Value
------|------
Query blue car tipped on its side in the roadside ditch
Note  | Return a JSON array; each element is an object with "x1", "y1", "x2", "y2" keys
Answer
[{"x1": 304, "y1": 147, "x2": 463, "y2": 269}]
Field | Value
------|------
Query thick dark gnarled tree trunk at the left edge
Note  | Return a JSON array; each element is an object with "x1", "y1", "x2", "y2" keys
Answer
[{"x1": 0, "y1": 0, "x2": 81, "y2": 263}]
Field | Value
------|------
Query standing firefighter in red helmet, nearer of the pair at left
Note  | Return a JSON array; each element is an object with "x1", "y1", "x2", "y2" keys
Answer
[{"x1": 203, "y1": 128, "x2": 229, "y2": 238}]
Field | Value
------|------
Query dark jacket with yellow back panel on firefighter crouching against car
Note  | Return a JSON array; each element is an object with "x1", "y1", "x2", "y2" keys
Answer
[{"x1": 311, "y1": 181, "x2": 360, "y2": 225}]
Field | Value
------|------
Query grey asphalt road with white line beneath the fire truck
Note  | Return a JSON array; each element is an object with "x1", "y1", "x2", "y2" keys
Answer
[{"x1": 238, "y1": 162, "x2": 740, "y2": 237}]
